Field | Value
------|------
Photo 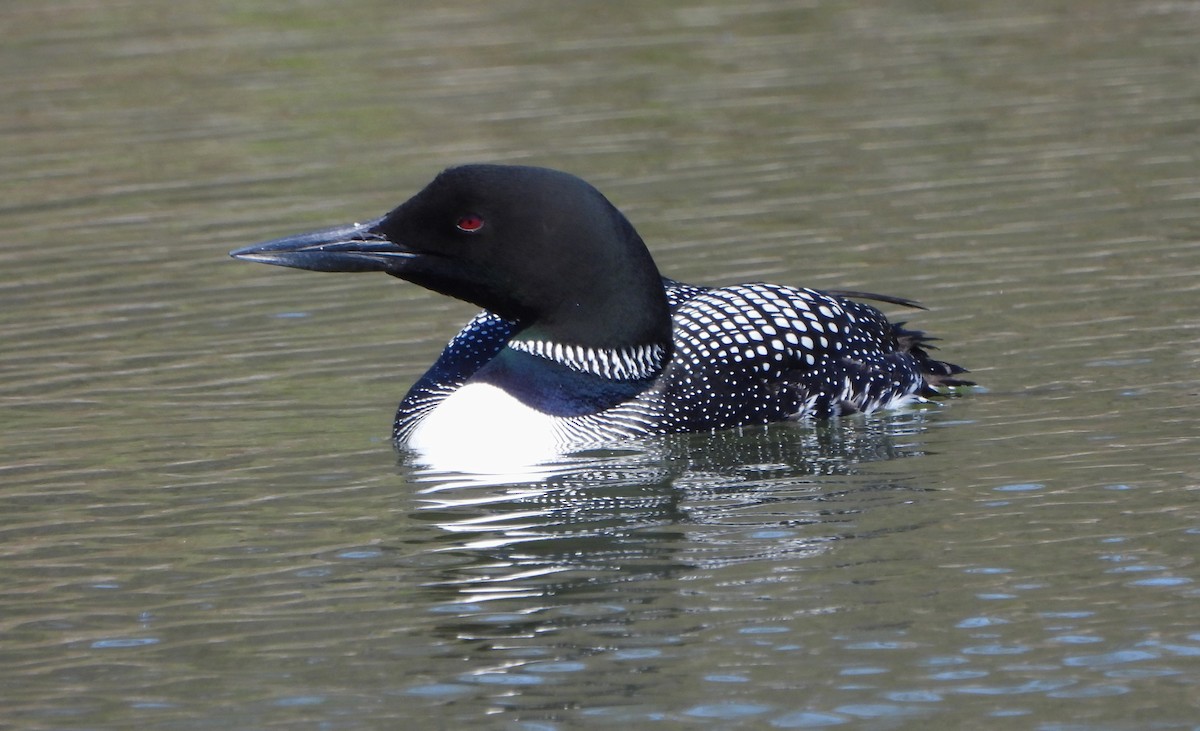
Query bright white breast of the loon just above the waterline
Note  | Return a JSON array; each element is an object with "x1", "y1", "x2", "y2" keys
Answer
[{"x1": 408, "y1": 383, "x2": 565, "y2": 471}]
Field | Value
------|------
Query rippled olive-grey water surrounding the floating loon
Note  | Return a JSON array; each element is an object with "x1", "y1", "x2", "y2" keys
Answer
[{"x1": 0, "y1": 0, "x2": 1200, "y2": 730}]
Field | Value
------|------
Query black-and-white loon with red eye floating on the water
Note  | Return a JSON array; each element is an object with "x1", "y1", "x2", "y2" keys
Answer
[{"x1": 230, "y1": 164, "x2": 970, "y2": 454}]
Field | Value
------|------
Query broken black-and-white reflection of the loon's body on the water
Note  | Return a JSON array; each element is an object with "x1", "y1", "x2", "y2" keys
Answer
[{"x1": 402, "y1": 411, "x2": 929, "y2": 611}]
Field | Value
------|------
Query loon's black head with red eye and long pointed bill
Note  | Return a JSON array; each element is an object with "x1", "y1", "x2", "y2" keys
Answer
[{"x1": 232, "y1": 164, "x2": 671, "y2": 348}]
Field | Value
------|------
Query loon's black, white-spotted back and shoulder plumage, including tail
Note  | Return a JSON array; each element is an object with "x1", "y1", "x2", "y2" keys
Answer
[{"x1": 392, "y1": 278, "x2": 970, "y2": 447}]
